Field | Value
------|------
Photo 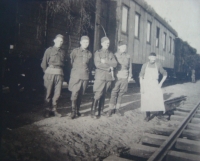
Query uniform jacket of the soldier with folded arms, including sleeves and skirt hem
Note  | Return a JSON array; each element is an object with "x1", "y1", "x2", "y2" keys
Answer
[{"x1": 94, "y1": 49, "x2": 117, "y2": 81}]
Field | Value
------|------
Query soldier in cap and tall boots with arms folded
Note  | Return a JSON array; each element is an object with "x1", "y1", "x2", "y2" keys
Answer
[{"x1": 91, "y1": 37, "x2": 117, "y2": 118}]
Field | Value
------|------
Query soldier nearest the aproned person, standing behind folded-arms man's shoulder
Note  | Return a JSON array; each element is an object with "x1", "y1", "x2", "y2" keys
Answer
[{"x1": 108, "y1": 41, "x2": 132, "y2": 117}]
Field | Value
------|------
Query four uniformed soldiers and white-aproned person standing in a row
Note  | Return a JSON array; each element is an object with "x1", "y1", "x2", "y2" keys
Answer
[{"x1": 41, "y1": 34, "x2": 167, "y2": 121}]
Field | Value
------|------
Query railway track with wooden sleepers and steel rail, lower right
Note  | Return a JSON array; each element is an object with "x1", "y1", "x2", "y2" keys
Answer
[{"x1": 104, "y1": 98, "x2": 200, "y2": 161}]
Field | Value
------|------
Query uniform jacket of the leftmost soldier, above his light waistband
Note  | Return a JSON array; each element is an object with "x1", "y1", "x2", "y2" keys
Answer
[{"x1": 41, "y1": 46, "x2": 65, "y2": 72}]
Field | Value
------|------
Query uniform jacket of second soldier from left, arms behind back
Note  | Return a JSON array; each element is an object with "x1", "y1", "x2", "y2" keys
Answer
[{"x1": 70, "y1": 47, "x2": 92, "y2": 80}]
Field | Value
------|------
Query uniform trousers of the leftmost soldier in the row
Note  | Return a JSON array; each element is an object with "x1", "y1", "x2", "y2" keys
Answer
[{"x1": 44, "y1": 73, "x2": 63, "y2": 106}]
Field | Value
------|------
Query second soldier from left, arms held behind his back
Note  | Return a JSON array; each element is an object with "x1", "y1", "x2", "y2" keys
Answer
[{"x1": 69, "y1": 36, "x2": 92, "y2": 119}]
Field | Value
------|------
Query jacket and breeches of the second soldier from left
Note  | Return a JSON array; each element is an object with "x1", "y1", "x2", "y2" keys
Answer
[{"x1": 69, "y1": 47, "x2": 92, "y2": 100}]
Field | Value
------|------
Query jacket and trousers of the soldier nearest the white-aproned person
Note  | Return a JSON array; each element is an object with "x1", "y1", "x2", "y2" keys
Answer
[{"x1": 110, "y1": 52, "x2": 132, "y2": 105}]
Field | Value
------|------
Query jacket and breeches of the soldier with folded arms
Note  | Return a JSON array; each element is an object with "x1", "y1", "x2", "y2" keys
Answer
[{"x1": 93, "y1": 49, "x2": 117, "y2": 100}]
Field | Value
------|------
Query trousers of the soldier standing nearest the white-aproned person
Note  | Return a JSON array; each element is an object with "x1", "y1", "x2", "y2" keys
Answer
[{"x1": 110, "y1": 78, "x2": 128, "y2": 105}]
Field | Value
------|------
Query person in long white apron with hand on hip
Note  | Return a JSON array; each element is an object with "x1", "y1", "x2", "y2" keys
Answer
[{"x1": 140, "y1": 53, "x2": 167, "y2": 121}]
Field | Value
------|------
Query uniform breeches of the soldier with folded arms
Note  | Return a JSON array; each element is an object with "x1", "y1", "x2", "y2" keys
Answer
[{"x1": 93, "y1": 80, "x2": 111, "y2": 100}]
